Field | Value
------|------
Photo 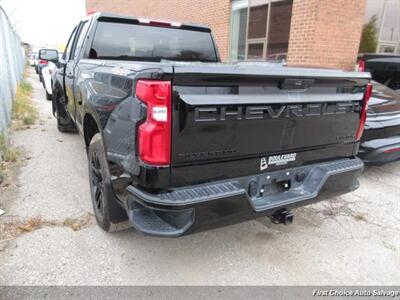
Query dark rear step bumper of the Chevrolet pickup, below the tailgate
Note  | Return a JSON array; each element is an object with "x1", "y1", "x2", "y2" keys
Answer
[{"x1": 127, "y1": 158, "x2": 364, "y2": 237}]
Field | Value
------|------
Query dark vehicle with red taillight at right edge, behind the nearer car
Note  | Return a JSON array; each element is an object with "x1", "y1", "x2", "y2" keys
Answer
[{"x1": 358, "y1": 53, "x2": 400, "y2": 91}]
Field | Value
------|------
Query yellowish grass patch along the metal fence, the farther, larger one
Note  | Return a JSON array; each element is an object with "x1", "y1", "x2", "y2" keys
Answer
[{"x1": 13, "y1": 80, "x2": 38, "y2": 129}]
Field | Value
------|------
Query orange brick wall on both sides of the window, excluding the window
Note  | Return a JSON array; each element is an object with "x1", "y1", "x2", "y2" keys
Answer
[{"x1": 86, "y1": 0, "x2": 366, "y2": 70}]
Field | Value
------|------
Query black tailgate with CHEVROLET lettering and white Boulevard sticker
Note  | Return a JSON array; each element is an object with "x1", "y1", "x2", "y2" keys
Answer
[{"x1": 171, "y1": 64, "x2": 369, "y2": 186}]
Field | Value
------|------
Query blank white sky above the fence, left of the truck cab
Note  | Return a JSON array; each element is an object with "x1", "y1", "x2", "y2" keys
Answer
[{"x1": 0, "y1": 0, "x2": 86, "y2": 50}]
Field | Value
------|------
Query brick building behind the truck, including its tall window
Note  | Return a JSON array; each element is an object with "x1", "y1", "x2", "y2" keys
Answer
[{"x1": 86, "y1": 0, "x2": 366, "y2": 70}]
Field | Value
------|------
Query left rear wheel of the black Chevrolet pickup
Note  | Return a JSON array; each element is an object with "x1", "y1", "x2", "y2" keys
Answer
[{"x1": 88, "y1": 133, "x2": 130, "y2": 232}]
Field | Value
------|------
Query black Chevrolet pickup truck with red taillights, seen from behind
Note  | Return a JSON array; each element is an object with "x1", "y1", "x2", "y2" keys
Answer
[{"x1": 53, "y1": 13, "x2": 371, "y2": 236}]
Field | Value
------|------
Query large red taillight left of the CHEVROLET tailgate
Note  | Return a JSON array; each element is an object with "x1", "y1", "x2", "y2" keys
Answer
[{"x1": 136, "y1": 80, "x2": 171, "y2": 166}]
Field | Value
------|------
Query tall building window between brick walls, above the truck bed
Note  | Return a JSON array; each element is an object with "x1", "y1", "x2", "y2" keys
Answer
[{"x1": 230, "y1": 0, "x2": 293, "y2": 61}]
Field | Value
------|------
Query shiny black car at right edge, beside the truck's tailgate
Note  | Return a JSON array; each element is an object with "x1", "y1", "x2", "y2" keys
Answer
[{"x1": 358, "y1": 81, "x2": 400, "y2": 164}]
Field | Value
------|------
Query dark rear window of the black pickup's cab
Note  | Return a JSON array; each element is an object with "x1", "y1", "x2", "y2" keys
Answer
[{"x1": 89, "y1": 22, "x2": 217, "y2": 62}]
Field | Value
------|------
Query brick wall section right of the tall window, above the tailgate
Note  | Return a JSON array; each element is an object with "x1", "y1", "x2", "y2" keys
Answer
[{"x1": 288, "y1": 0, "x2": 366, "y2": 70}]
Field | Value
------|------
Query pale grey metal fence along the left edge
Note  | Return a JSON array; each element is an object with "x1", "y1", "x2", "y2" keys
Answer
[{"x1": 0, "y1": 6, "x2": 25, "y2": 133}]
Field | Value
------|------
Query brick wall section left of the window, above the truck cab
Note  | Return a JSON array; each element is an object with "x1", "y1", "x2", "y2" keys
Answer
[{"x1": 86, "y1": 0, "x2": 230, "y2": 61}]
